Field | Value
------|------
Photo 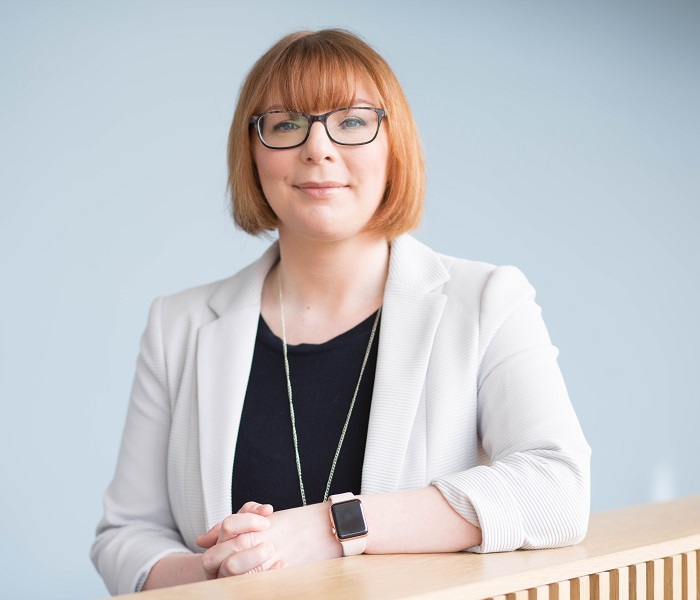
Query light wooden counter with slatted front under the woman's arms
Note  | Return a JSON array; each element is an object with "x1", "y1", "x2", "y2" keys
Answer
[{"x1": 109, "y1": 496, "x2": 700, "y2": 600}]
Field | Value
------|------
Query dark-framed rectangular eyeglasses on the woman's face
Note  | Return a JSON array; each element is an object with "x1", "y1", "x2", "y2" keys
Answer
[{"x1": 250, "y1": 106, "x2": 386, "y2": 150}]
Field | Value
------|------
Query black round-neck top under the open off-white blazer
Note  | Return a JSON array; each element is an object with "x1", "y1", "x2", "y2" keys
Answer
[{"x1": 231, "y1": 313, "x2": 379, "y2": 512}]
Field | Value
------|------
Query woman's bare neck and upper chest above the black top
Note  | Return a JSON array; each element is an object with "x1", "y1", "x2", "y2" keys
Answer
[{"x1": 262, "y1": 231, "x2": 389, "y2": 344}]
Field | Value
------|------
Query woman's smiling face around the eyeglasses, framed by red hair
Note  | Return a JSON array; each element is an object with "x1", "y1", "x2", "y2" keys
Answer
[{"x1": 253, "y1": 82, "x2": 389, "y2": 241}]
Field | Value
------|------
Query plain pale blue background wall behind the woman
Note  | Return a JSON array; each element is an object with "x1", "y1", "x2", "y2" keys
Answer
[{"x1": 0, "y1": 0, "x2": 700, "y2": 599}]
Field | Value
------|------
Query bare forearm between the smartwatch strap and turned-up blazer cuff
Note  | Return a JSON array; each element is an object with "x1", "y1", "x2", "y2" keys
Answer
[{"x1": 360, "y1": 485, "x2": 481, "y2": 554}]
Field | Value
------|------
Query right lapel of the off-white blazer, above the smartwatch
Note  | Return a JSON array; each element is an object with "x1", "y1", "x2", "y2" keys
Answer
[{"x1": 362, "y1": 236, "x2": 449, "y2": 493}]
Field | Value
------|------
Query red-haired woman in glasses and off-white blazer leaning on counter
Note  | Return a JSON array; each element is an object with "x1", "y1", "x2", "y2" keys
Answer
[{"x1": 92, "y1": 30, "x2": 590, "y2": 592}]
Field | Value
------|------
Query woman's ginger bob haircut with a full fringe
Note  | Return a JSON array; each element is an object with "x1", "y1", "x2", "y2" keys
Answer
[{"x1": 228, "y1": 29, "x2": 425, "y2": 240}]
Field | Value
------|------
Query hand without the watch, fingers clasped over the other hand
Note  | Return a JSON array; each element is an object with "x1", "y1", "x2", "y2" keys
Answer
[{"x1": 196, "y1": 502, "x2": 286, "y2": 579}]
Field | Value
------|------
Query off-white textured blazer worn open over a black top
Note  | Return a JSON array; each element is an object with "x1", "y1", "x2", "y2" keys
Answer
[{"x1": 92, "y1": 236, "x2": 590, "y2": 593}]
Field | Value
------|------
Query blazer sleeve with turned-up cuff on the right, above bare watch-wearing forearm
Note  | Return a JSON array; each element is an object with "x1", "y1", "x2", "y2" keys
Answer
[{"x1": 432, "y1": 266, "x2": 590, "y2": 552}]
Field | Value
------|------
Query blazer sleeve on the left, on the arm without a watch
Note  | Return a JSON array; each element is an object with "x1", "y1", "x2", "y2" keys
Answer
[{"x1": 91, "y1": 299, "x2": 190, "y2": 594}]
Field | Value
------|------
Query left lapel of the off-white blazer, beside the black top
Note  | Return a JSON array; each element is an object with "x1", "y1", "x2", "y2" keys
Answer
[{"x1": 197, "y1": 244, "x2": 279, "y2": 528}]
